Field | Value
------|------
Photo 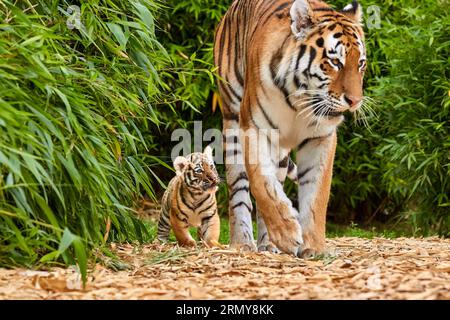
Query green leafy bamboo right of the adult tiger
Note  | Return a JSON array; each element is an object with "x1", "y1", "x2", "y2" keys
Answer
[{"x1": 332, "y1": 0, "x2": 450, "y2": 236}]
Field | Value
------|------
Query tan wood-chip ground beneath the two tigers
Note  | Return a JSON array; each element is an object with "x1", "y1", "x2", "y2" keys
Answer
[{"x1": 0, "y1": 238, "x2": 450, "y2": 299}]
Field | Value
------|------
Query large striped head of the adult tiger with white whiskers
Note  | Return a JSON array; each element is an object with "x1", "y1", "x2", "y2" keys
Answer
[{"x1": 290, "y1": 0, "x2": 366, "y2": 118}]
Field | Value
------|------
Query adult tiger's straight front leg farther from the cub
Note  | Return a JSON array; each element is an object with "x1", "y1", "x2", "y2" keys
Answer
[{"x1": 297, "y1": 131, "x2": 337, "y2": 256}]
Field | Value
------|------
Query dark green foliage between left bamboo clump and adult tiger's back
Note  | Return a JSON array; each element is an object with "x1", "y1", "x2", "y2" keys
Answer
[{"x1": 158, "y1": 0, "x2": 227, "y2": 128}]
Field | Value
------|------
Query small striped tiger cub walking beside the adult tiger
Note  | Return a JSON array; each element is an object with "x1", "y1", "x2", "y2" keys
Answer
[{"x1": 158, "y1": 147, "x2": 220, "y2": 247}]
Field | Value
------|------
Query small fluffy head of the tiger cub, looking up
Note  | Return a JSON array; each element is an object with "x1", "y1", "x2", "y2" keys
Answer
[{"x1": 173, "y1": 146, "x2": 220, "y2": 192}]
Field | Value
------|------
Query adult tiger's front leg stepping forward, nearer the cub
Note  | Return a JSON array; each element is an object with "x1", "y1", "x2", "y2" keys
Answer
[{"x1": 241, "y1": 128, "x2": 303, "y2": 256}]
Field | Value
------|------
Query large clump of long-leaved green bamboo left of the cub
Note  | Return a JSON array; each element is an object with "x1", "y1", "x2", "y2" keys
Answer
[{"x1": 0, "y1": 0, "x2": 169, "y2": 275}]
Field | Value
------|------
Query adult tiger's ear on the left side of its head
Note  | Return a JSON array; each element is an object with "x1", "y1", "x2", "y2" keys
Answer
[{"x1": 291, "y1": 0, "x2": 317, "y2": 39}]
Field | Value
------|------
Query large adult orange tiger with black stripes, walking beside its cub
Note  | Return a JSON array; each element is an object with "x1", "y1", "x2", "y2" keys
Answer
[{"x1": 214, "y1": 0, "x2": 366, "y2": 256}]
